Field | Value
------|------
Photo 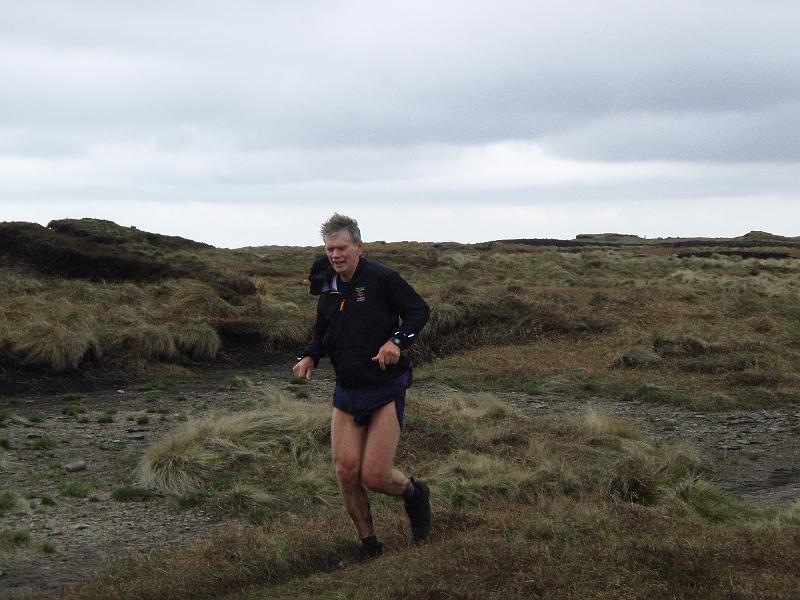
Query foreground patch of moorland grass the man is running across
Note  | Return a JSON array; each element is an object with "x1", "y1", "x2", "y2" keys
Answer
[{"x1": 61, "y1": 393, "x2": 800, "y2": 599}]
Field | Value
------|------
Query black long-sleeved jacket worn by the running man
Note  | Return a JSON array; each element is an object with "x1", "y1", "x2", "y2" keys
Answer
[{"x1": 302, "y1": 258, "x2": 430, "y2": 387}]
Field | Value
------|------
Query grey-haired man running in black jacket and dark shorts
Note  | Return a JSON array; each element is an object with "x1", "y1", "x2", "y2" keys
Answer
[{"x1": 293, "y1": 214, "x2": 431, "y2": 567}]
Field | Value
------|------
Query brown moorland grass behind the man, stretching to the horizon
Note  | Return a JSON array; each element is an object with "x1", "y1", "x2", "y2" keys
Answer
[{"x1": 0, "y1": 220, "x2": 800, "y2": 409}]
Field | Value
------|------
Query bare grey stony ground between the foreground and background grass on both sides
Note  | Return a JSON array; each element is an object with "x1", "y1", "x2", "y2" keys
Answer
[{"x1": 0, "y1": 365, "x2": 800, "y2": 597}]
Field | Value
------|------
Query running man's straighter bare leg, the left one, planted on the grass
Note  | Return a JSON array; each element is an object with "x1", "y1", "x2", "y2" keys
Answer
[{"x1": 331, "y1": 408, "x2": 375, "y2": 540}]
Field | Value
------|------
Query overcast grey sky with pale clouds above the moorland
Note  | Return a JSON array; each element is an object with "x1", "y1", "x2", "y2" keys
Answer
[{"x1": 0, "y1": 0, "x2": 800, "y2": 247}]
